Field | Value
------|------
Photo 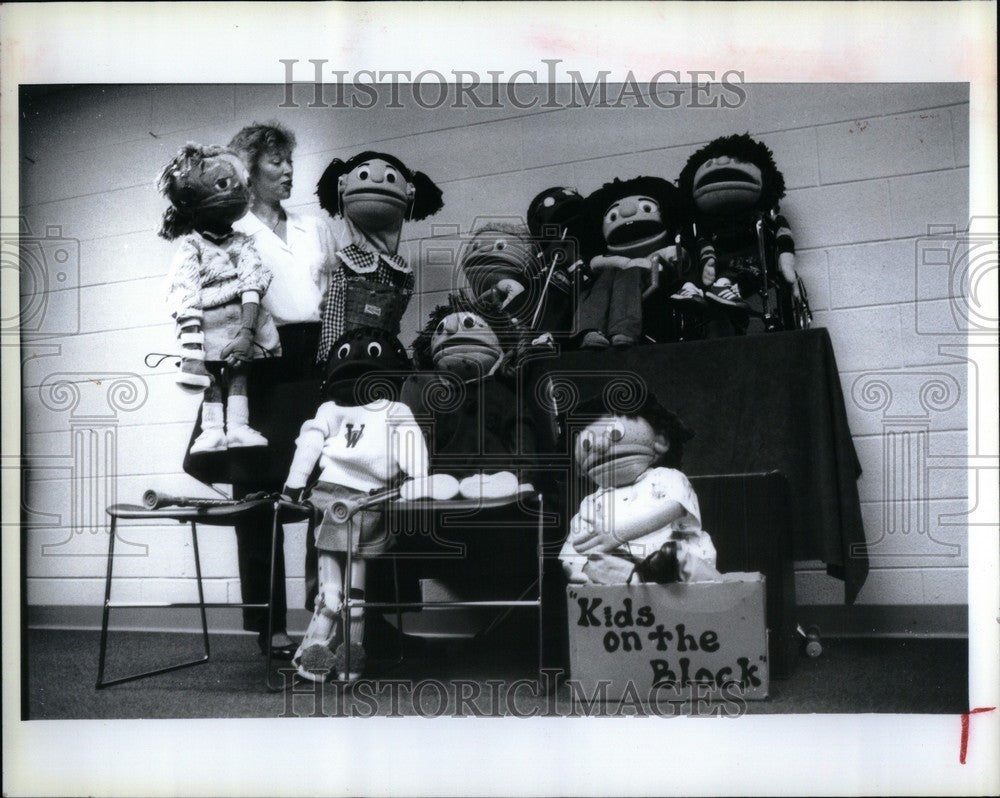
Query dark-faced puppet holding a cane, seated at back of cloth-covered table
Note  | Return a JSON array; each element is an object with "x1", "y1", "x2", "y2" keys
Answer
[{"x1": 528, "y1": 186, "x2": 597, "y2": 337}]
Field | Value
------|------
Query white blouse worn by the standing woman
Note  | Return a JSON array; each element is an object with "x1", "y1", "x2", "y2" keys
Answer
[{"x1": 233, "y1": 210, "x2": 338, "y2": 327}]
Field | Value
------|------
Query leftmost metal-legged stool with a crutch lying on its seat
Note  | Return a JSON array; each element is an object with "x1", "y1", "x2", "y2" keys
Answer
[{"x1": 96, "y1": 496, "x2": 313, "y2": 692}]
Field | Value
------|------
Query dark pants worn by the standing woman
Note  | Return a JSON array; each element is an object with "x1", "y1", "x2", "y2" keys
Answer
[{"x1": 233, "y1": 323, "x2": 320, "y2": 632}]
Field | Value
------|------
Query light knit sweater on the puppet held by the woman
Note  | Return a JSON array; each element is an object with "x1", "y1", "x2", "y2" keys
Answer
[{"x1": 167, "y1": 232, "x2": 271, "y2": 319}]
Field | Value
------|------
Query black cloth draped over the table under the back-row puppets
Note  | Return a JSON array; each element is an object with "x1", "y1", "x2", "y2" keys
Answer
[{"x1": 525, "y1": 329, "x2": 868, "y2": 603}]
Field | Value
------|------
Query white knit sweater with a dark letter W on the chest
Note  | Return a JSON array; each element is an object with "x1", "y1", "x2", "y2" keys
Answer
[{"x1": 287, "y1": 401, "x2": 427, "y2": 491}]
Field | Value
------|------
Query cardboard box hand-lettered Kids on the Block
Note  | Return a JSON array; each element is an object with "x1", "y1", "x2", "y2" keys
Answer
[{"x1": 567, "y1": 573, "x2": 768, "y2": 702}]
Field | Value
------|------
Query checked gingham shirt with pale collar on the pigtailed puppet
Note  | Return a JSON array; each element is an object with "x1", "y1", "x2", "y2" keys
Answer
[{"x1": 316, "y1": 244, "x2": 414, "y2": 363}]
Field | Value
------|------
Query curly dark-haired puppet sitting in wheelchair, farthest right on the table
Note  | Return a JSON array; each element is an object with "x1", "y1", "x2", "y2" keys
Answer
[{"x1": 672, "y1": 133, "x2": 808, "y2": 333}]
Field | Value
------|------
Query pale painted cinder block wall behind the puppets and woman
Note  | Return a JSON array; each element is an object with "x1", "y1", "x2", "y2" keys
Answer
[{"x1": 20, "y1": 84, "x2": 969, "y2": 624}]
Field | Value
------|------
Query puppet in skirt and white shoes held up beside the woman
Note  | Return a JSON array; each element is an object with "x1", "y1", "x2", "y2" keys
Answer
[{"x1": 157, "y1": 143, "x2": 281, "y2": 454}]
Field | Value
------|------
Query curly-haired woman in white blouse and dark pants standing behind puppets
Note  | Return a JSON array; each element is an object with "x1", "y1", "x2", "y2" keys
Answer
[{"x1": 214, "y1": 123, "x2": 336, "y2": 659}]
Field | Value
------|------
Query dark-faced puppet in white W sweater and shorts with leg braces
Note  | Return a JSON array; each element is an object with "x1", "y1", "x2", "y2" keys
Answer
[{"x1": 283, "y1": 328, "x2": 427, "y2": 681}]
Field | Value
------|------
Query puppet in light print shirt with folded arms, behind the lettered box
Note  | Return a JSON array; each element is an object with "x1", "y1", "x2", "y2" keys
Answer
[{"x1": 559, "y1": 394, "x2": 720, "y2": 584}]
